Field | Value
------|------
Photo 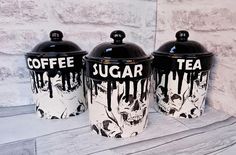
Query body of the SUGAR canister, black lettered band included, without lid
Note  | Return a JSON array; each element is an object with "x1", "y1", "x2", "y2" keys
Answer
[{"x1": 86, "y1": 60, "x2": 151, "y2": 138}]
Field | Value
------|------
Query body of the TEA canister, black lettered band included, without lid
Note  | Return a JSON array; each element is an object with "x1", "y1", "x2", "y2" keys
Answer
[{"x1": 153, "y1": 56, "x2": 211, "y2": 118}]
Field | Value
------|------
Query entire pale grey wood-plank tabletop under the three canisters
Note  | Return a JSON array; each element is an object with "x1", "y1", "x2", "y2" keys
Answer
[{"x1": 0, "y1": 105, "x2": 236, "y2": 155}]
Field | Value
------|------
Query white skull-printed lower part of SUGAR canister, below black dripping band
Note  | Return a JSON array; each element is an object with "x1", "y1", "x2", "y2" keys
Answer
[{"x1": 87, "y1": 78, "x2": 150, "y2": 138}]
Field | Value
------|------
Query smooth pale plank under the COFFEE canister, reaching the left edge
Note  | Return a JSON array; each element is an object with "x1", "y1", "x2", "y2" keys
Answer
[{"x1": 0, "y1": 112, "x2": 89, "y2": 144}]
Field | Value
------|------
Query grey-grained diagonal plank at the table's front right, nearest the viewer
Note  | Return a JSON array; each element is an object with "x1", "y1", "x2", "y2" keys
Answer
[{"x1": 99, "y1": 117, "x2": 236, "y2": 155}]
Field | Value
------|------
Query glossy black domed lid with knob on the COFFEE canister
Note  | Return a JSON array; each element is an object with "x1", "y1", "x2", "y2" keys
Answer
[{"x1": 27, "y1": 30, "x2": 86, "y2": 56}]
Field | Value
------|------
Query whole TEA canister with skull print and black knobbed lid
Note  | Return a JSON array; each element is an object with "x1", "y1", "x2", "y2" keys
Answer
[{"x1": 152, "y1": 30, "x2": 213, "y2": 118}]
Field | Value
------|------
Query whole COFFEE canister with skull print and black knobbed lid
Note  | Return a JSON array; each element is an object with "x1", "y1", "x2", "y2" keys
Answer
[{"x1": 25, "y1": 30, "x2": 87, "y2": 119}]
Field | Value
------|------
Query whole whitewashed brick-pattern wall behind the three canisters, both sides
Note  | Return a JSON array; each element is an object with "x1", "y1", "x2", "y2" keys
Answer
[{"x1": 0, "y1": 0, "x2": 236, "y2": 116}]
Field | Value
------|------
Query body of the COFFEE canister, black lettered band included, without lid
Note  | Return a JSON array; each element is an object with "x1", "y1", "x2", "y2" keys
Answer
[{"x1": 26, "y1": 54, "x2": 87, "y2": 119}]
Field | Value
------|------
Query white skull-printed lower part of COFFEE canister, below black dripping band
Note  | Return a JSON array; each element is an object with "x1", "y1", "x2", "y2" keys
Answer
[{"x1": 30, "y1": 70, "x2": 87, "y2": 119}]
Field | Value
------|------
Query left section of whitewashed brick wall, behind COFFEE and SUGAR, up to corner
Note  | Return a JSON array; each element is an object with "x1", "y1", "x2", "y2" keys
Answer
[{"x1": 0, "y1": 0, "x2": 156, "y2": 106}]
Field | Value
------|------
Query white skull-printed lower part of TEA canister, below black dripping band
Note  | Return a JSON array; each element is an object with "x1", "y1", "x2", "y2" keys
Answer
[{"x1": 154, "y1": 71, "x2": 210, "y2": 118}]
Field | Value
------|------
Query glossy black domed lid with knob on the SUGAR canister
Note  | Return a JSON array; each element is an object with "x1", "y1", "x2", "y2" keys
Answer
[{"x1": 86, "y1": 30, "x2": 148, "y2": 61}]
